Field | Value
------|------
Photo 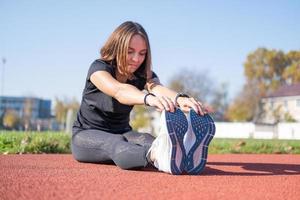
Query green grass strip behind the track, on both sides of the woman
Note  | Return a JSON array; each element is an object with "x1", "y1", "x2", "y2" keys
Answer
[{"x1": 0, "y1": 131, "x2": 300, "y2": 154}]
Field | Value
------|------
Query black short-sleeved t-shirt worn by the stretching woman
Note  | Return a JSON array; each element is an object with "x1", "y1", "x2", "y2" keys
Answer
[{"x1": 73, "y1": 59, "x2": 157, "y2": 134}]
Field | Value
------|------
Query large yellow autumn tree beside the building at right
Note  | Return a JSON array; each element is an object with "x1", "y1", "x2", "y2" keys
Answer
[{"x1": 226, "y1": 48, "x2": 300, "y2": 121}]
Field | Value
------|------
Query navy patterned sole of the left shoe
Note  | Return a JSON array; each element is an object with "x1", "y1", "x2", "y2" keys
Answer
[{"x1": 166, "y1": 109, "x2": 188, "y2": 175}]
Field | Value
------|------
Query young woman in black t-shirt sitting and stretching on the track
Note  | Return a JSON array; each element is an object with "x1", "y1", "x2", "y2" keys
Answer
[{"x1": 72, "y1": 21, "x2": 214, "y2": 174}]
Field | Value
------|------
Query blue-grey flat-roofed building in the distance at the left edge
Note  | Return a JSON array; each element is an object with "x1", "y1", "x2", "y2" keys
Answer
[{"x1": 0, "y1": 96, "x2": 51, "y2": 119}]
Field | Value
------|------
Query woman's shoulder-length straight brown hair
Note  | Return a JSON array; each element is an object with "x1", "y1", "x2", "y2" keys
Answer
[{"x1": 100, "y1": 21, "x2": 152, "y2": 80}]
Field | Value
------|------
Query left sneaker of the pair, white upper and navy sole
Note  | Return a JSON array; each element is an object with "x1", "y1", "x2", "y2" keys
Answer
[{"x1": 148, "y1": 109, "x2": 188, "y2": 175}]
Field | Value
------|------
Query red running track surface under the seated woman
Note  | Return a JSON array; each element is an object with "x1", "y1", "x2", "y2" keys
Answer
[{"x1": 0, "y1": 154, "x2": 300, "y2": 200}]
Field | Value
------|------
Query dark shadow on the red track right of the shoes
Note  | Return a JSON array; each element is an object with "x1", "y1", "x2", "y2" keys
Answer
[{"x1": 201, "y1": 162, "x2": 300, "y2": 176}]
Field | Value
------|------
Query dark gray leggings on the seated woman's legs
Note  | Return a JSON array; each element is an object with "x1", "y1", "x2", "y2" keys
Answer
[{"x1": 71, "y1": 129, "x2": 154, "y2": 169}]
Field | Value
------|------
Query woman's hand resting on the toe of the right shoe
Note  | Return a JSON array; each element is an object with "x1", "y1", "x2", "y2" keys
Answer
[{"x1": 177, "y1": 97, "x2": 212, "y2": 115}]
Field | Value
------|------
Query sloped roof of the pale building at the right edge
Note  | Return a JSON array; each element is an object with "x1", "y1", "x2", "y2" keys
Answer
[{"x1": 266, "y1": 83, "x2": 300, "y2": 98}]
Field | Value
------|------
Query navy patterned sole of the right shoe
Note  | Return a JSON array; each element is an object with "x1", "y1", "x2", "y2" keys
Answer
[{"x1": 186, "y1": 110, "x2": 216, "y2": 175}]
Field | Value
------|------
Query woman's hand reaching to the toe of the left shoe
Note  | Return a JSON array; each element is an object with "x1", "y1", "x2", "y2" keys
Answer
[{"x1": 146, "y1": 95, "x2": 175, "y2": 112}]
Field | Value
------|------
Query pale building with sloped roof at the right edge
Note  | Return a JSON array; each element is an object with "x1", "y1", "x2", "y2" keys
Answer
[{"x1": 261, "y1": 84, "x2": 300, "y2": 124}]
